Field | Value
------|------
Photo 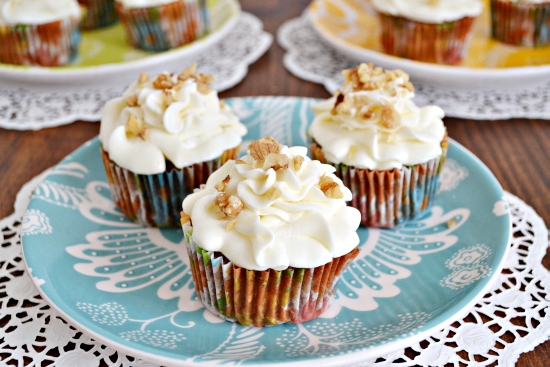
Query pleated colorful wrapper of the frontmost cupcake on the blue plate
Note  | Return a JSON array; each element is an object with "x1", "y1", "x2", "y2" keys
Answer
[{"x1": 183, "y1": 223, "x2": 359, "y2": 326}]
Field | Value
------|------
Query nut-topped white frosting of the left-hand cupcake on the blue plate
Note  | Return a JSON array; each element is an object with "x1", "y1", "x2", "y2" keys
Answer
[{"x1": 99, "y1": 68, "x2": 247, "y2": 174}]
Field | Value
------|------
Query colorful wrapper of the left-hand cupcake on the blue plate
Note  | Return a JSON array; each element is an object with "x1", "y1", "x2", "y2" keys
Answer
[{"x1": 101, "y1": 147, "x2": 238, "y2": 227}]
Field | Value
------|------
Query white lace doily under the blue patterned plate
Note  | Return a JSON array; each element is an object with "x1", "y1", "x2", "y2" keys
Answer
[{"x1": 0, "y1": 172, "x2": 550, "y2": 367}]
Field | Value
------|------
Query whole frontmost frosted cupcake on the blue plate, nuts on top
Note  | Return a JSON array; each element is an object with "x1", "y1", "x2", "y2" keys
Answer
[{"x1": 181, "y1": 138, "x2": 360, "y2": 326}]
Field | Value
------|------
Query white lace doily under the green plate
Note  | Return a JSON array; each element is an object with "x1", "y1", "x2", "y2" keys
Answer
[{"x1": 0, "y1": 13, "x2": 273, "y2": 130}]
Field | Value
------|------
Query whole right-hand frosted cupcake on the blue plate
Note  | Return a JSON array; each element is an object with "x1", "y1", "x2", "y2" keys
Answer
[{"x1": 308, "y1": 64, "x2": 447, "y2": 227}]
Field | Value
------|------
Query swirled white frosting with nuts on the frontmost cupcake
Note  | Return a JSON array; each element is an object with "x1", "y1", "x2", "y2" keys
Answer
[{"x1": 183, "y1": 138, "x2": 361, "y2": 270}]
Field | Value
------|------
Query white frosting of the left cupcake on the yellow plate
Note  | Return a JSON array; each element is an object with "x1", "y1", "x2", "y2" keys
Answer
[{"x1": 371, "y1": 0, "x2": 483, "y2": 23}]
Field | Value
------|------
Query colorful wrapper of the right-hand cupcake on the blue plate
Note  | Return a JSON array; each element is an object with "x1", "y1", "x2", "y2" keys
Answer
[{"x1": 310, "y1": 138, "x2": 448, "y2": 228}]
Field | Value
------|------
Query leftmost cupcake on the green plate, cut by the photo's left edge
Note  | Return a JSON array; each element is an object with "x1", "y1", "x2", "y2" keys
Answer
[{"x1": 0, "y1": 0, "x2": 81, "y2": 66}]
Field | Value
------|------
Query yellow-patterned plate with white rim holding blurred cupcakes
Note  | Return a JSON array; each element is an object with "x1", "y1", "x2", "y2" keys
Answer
[{"x1": 306, "y1": 0, "x2": 550, "y2": 89}]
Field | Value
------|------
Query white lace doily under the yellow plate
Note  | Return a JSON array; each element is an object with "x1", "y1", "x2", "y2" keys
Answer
[{"x1": 277, "y1": 17, "x2": 550, "y2": 120}]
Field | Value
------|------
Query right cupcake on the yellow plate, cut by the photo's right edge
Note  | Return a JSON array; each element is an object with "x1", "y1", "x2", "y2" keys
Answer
[{"x1": 491, "y1": 0, "x2": 550, "y2": 47}]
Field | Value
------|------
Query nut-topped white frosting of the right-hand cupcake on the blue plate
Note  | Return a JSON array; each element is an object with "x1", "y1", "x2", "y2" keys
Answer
[{"x1": 309, "y1": 64, "x2": 446, "y2": 170}]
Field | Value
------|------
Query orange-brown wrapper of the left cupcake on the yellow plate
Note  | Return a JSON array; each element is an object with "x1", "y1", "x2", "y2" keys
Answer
[{"x1": 379, "y1": 13, "x2": 475, "y2": 65}]
